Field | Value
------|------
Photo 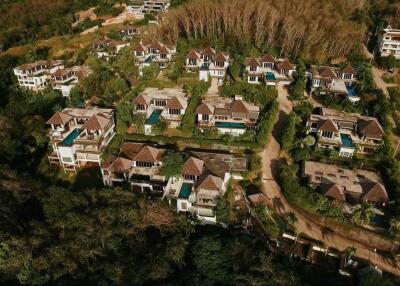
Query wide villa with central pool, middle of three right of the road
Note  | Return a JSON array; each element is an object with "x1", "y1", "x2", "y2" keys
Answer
[{"x1": 307, "y1": 108, "x2": 385, "y2": 158}]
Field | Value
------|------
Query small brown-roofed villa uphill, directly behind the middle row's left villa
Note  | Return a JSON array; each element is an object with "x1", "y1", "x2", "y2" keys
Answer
[{"x1": 133, "y1": 40, "x2": 176, "y2": 75}]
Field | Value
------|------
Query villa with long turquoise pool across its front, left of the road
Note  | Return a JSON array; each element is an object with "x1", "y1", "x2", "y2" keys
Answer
[{"x1": 195, "y1": 95, "x2": 260, "y2": 136}]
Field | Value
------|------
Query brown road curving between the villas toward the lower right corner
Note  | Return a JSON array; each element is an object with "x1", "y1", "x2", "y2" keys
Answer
[{"x1": 262, "y1": 82, "x2": 400, "y2": 275}]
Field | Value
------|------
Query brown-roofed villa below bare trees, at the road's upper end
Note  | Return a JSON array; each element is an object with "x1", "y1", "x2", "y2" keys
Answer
[{"x1": 245, "y1": 55, "x2": 296, "y2": 87}]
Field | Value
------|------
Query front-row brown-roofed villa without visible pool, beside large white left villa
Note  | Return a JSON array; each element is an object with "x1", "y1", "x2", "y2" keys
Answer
[{"x1": 101, "y1": 142, "x2": 167, "y2": 195}]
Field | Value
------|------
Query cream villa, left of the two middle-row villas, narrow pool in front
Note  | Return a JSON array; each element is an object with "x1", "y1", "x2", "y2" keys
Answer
[{"x1": 133, "y1": 88, "x2": 188, "y2": 135}]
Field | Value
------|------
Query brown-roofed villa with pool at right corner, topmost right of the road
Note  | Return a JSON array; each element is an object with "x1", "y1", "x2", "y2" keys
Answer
[{"x1": 310, "y1": 65, "x2": 360, "y2": 103}]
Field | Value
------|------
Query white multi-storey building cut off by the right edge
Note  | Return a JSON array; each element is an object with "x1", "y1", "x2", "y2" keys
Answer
[{"x1": 378, "y1": 26, "x2": 400, "y2": 59}]
